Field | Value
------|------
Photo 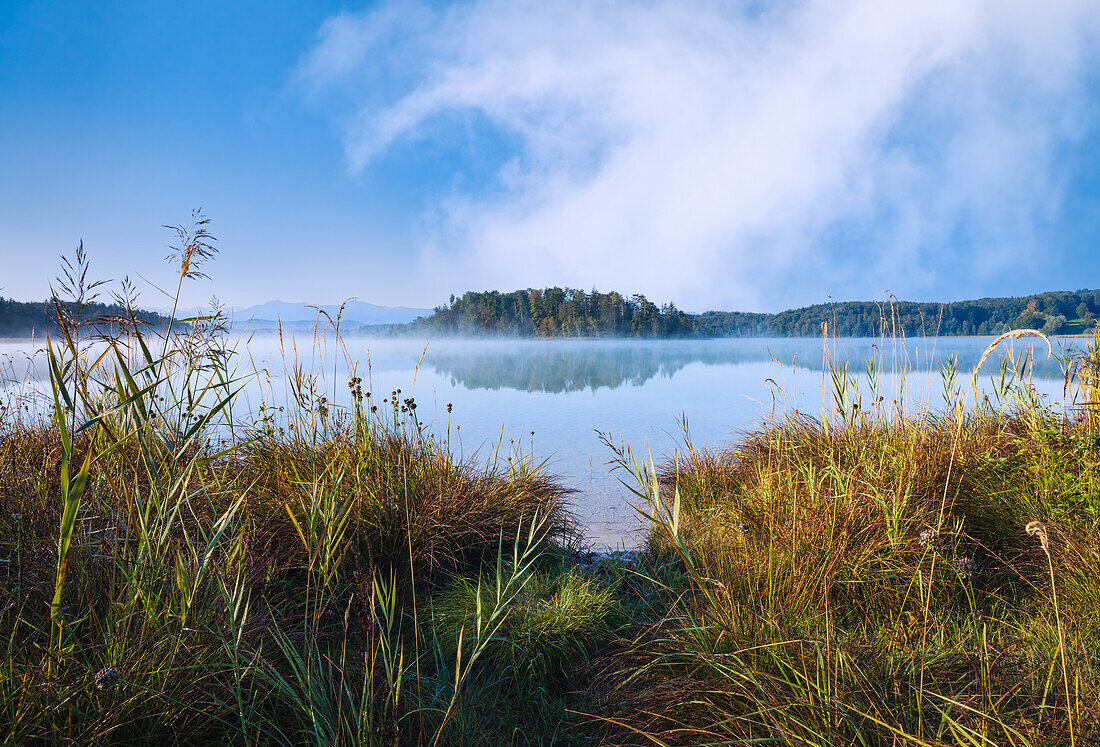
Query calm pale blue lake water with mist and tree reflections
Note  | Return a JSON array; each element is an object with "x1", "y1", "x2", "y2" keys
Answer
[{"x1": 0, "y1": 337, "x2": 1076, "y2": 546}]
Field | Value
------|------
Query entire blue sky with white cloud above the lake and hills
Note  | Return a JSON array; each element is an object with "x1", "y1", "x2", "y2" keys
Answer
[{"x1": 0, "y1": 0, "x2": 1100, "y2": 310}]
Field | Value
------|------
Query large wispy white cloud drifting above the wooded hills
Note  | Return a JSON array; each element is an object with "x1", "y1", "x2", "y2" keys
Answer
[{"x1": 298, "y1": 0, "x2": 1100, "y2": 309}]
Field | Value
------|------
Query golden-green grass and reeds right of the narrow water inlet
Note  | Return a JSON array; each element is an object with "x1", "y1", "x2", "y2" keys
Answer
[{"x1": 598, "y1": 334, "x2": 1100, "y2": 745}]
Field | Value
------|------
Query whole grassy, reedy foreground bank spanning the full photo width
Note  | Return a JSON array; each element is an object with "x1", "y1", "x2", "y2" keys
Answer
[{"x1": 0, "y1": 228, "x2": 1100, "y2": 745}]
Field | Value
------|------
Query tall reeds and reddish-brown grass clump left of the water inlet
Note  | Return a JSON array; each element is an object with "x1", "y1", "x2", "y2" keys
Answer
[{"x1": 0, "y1": 225, "x2": 594, "y2": 745}]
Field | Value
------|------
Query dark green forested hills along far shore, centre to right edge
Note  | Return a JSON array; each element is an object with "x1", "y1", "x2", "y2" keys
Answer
[{"x1": 394, "y1": 288, "x2": 1100, "y2": 338}]
